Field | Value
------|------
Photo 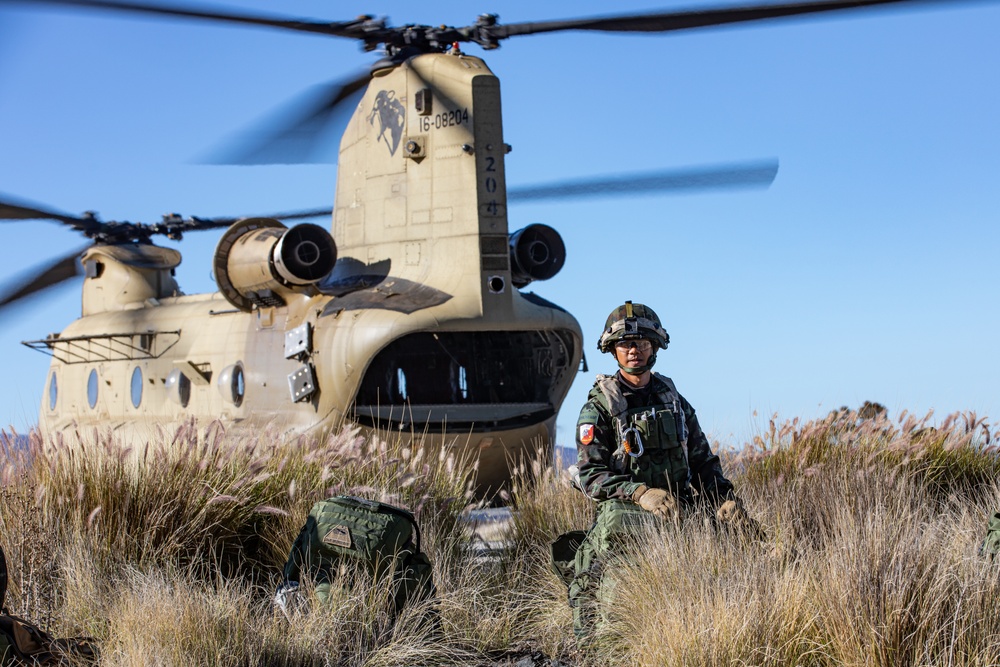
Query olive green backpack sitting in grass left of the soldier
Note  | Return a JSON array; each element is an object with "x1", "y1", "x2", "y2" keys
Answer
[{"x1": 284, "y1": 496, "x2": 434, "y2": 614}]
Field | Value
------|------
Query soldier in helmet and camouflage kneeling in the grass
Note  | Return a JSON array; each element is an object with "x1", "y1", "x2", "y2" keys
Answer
[{"x1": 569, "y1": 301, "x2": 762, "y2": 637}]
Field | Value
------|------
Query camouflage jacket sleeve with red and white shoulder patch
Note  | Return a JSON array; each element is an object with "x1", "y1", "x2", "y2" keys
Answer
[{"x1": 576, "y1": 399, "x2": 641, "y2": 500}]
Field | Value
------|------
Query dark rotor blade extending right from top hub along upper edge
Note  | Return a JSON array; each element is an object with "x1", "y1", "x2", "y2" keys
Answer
[{"x1": 496, "y1": 0, "x2": 980, "y2": 39}]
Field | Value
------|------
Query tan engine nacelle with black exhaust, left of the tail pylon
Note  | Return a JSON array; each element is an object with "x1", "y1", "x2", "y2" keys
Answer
[{"x1": 213, "y1": 218, "x2": 337, "y2": 311}]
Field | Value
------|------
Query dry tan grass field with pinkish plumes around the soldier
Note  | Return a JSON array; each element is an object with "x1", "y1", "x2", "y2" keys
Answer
[{"x1": 0, "y1": 412, "x2": 1000, "y2": 667}]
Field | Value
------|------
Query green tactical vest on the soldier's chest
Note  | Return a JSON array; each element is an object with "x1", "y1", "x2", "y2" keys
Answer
[{"x1": 591, "y1": 373, "x2": 691, "y2": 495}]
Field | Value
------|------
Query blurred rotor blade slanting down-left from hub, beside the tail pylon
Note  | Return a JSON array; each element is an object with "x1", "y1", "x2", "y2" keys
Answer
[{"x1": 199, "y1": 70, "x2": 371, "y2": 165}]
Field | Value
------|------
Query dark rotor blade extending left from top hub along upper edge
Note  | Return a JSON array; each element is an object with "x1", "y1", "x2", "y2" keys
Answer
[{"x1": 0, "y1": 0, "x2": 372, "y2": 38}]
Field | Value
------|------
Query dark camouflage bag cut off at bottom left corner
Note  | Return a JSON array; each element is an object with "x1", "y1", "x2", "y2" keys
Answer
[{"x1": 0, "y1": 547, "x2": 97, "y2": 667}]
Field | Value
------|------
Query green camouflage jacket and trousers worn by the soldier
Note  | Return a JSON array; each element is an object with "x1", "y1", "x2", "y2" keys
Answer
[{"x1": 569, "y1": 373, "x2": 735, "y2": 637}]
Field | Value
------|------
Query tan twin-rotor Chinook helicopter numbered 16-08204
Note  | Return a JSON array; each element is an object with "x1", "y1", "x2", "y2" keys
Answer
[{"x1": 0, "y1": 0, "x2": 984, "y2": 485}]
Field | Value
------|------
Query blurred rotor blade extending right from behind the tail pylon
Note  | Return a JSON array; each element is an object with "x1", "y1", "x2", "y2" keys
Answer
[{"x1": 507, "y1": 160, "x2": 778, "y2": 203}]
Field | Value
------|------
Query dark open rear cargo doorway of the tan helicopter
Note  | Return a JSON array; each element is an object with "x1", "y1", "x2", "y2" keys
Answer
[{"x1": 355, "y1": 330, "x2": 574, "y2": 431}]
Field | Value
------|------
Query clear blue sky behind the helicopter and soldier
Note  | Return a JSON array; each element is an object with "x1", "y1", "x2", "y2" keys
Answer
[{"x1": 0, "y1": 0, "x2": 1000, "y2": 444}]
